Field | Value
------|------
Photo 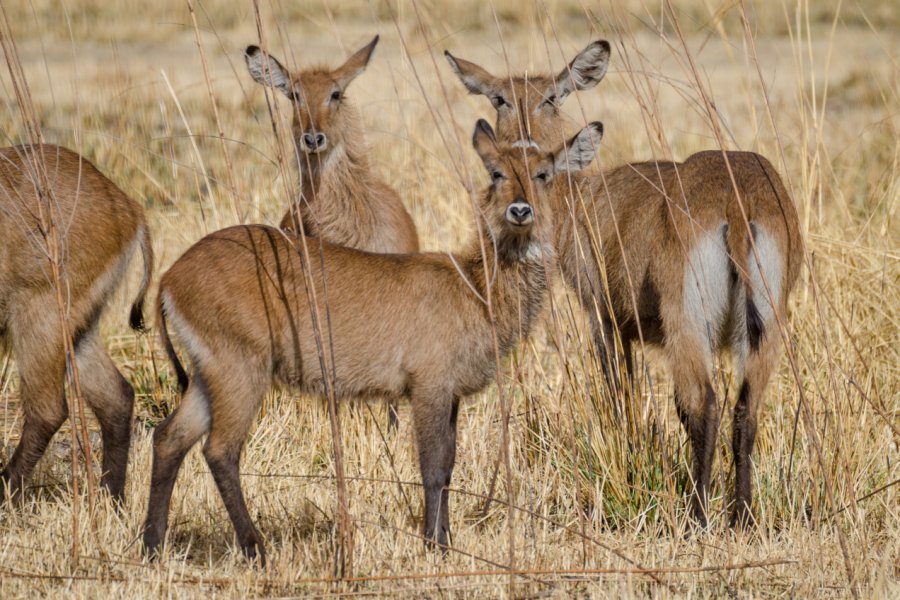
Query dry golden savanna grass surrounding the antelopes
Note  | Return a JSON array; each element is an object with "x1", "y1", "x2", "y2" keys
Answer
[{"x1": 0, "y1": 0, "x2": 900, "y2": 598}]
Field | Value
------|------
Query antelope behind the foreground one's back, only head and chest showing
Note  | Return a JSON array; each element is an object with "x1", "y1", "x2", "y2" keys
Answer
[{"x1": 244, "y1": 35, "x2": 419, "y2": 429}]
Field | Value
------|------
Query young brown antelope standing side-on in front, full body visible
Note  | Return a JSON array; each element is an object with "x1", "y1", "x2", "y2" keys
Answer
[{"x1": 144, "y1": 120, "x2": 603, "y2": 562}]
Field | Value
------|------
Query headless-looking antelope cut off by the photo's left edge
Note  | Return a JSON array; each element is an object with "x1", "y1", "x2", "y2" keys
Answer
[{"x1": 0, "y1": 145, "x2": 153, "y2": 501}]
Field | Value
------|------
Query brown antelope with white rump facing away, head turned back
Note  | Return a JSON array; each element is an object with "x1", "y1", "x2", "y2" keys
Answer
[{"x1": 447, "y1": 42, "x2": 803, "y2": 524}]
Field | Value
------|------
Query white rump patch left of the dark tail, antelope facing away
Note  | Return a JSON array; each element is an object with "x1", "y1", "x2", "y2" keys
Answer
[{"x1": 683, "y1": 221, "x2": 731, "y2": 355}]
